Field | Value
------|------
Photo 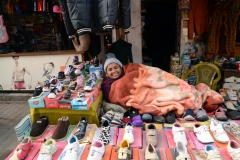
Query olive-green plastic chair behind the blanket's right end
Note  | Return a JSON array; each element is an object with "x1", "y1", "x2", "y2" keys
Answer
[{"x1": 181, "y1": 62, "x2": 221, "y2": 91}]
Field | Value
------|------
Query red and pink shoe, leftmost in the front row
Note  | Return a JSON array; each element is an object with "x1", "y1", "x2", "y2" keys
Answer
[{"x1": 9, "y1": 138, "x2": 32, "y2": 160}]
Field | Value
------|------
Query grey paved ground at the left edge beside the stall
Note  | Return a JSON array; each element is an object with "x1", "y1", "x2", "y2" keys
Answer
[{"x1": 0, "y1": 102, "x2": 29, "y2": 160}]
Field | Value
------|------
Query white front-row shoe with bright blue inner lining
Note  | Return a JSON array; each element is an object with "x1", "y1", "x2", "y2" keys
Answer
[{"x1": 61, "y1": 135, "x2": 79, "y2": 160}]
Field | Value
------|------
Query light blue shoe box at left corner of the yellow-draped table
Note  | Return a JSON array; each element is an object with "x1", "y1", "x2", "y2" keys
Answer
[{"x1": 28, "y1": 92, "x2": 50, "y2": 108}]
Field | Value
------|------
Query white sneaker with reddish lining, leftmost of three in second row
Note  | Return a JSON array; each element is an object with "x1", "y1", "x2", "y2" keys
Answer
[{"x1": 172, "y1": 123, "x2": 187, "y2": 146}]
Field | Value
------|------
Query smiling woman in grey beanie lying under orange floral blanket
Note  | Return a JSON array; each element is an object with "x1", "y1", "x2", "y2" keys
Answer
[{"x1": 101, "y1": 58, "x2": 224, "y2": 117}]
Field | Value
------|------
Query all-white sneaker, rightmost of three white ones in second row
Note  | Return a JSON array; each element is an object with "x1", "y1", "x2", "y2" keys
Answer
[{"x1": 210, "y1": 118, "x2": 229, "y2": 143}]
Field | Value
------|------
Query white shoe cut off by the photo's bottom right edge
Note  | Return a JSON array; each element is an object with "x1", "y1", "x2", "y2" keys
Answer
[{"x1": 227, "y1": 140, "x2": 240, "y2": 160}]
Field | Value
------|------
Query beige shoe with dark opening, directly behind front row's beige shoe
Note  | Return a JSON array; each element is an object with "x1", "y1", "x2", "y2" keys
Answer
[{"x1": 146, "y1": 124, "x2": 157, "y2": 147}]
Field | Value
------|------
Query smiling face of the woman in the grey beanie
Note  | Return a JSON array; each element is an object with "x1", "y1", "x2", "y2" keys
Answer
[{"x1": 106, "y1": 63, "x2": 122, "y2": 79}]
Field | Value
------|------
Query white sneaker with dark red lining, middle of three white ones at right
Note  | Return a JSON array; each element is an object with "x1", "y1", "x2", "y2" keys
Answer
[{"x1": 193, "y1": 123, "x2": 214, "y2": 143}]
